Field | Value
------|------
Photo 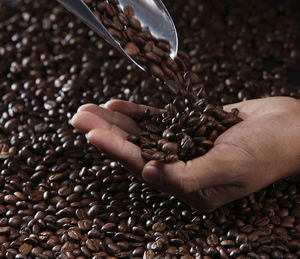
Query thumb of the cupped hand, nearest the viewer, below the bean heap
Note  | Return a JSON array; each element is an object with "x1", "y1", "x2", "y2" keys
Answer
[{"x1": 142, "y1": 144, "x2": 245, "y2": 193}]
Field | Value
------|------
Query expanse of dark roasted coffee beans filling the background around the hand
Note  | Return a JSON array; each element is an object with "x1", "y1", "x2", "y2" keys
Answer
[{"x1": 0, "y1": 0, "x2": 300, "y2": 259}]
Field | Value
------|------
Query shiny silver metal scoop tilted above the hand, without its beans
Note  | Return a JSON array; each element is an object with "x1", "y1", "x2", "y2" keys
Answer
[{"x1": 58, "y1": 0, "x2": 178, "y2": 70}]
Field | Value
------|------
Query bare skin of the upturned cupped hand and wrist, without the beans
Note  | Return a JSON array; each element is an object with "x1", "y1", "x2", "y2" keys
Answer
[{"x1": 71, "y1": 97, "x2": 300, "y2": 212}]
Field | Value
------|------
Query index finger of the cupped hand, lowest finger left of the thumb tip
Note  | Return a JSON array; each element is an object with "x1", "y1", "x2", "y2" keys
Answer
[{"x1": 86, "y1": 128, "x2": 145, "y2": 175}]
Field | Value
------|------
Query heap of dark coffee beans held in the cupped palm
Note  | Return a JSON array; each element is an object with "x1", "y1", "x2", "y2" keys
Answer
[{"x1": 128, "y1": 97, "x2": 241, "y2": 162}]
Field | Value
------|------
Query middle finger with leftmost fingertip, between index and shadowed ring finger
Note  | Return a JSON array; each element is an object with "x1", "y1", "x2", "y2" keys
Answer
[{"x1": 71, "y1": 111, "x2": 128, "y2": 139}]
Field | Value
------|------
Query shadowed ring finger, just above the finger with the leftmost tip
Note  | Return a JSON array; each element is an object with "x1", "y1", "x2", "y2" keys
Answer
[{"x1": 78, "y1": 104, "x2": 140, "y2": 134}]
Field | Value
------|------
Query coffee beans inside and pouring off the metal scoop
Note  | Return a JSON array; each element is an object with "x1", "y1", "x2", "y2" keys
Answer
[{"x1": 85, "y1": 0, "x2": 202, "y2": 101}]
